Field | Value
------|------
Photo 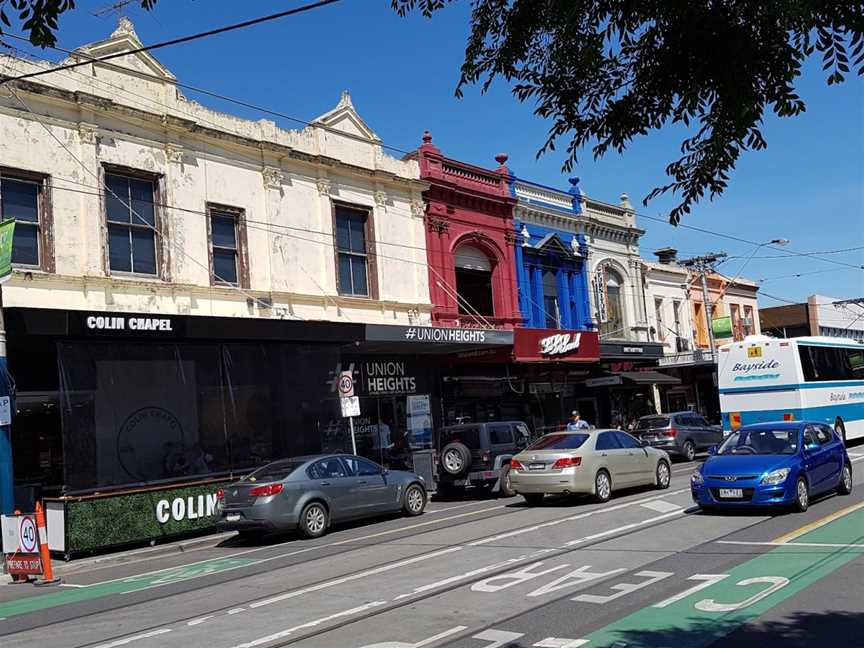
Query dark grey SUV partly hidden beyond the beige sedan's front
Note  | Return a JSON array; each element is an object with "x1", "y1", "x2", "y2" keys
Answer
[{"x1": 633, "y1": 412, "x2": 723, "y2": 461}]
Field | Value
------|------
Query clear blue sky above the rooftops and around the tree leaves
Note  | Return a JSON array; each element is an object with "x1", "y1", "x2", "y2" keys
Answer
[{"x1": 8, "y1": 0, "x2": 864, "y2": 307}]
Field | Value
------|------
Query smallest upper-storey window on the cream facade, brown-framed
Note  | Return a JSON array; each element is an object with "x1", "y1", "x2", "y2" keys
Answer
[{"x1": 207, "y1": 205, "x2": 249, "y2": 288}]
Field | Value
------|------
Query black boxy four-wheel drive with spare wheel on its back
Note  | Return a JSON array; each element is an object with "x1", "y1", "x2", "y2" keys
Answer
[{"x1": 435, "y1": 421, "x2": 531, "y2": 497}]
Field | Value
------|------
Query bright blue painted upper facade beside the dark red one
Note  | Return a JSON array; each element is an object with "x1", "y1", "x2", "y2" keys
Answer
[{"x1": 511, "y1": 178, "x2": 594, "y2": 331}]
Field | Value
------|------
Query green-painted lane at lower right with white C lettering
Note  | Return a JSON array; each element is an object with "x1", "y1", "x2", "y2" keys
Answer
[{"x1": 568, "y1": 498, "x2": 864, "y2": 648}]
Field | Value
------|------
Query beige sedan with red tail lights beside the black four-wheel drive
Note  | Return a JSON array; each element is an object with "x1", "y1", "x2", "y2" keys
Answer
[{"x1": 510, "y1": 430, "x2": 672, "y2": 505}]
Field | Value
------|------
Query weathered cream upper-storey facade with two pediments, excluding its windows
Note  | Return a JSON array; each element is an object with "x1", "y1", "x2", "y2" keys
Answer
[{"x1": 0, "y1": 19, "x2": 431, "y2": 324}]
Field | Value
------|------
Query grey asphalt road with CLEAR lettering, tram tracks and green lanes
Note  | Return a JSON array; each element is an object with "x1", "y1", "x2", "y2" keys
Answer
[{"x1": 0, "y1": 445, "x2": 864, "y2": 648}]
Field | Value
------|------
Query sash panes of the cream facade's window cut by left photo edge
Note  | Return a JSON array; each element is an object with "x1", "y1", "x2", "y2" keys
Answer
[{"x1": 0, "y1": 173, "x2": 44, "y2": 268}]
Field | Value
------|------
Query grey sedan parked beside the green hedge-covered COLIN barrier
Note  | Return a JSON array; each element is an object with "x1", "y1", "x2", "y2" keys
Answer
[{"x1": 216, "y1": 454, "x2": 427, "y2": 538}]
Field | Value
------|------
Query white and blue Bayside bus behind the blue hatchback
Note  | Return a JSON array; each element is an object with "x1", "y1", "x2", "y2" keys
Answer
[{"x1": 717, "y1": 335, "x2": 864, "y2": 440}]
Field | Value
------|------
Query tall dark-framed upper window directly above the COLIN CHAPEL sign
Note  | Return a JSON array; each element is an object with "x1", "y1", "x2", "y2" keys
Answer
[{"x1": 105, "y1": 172, "x2": 158, "y2": 275}]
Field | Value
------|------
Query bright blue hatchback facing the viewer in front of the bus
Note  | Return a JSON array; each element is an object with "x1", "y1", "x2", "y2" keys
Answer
[{"x1": 690, "y1": 421, "x2": 852, "y2": 511}]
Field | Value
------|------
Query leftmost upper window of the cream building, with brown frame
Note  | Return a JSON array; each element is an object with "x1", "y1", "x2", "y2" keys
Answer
[{"x1": 0, "y1": 169, "x2": 54, "y2": 272}]
